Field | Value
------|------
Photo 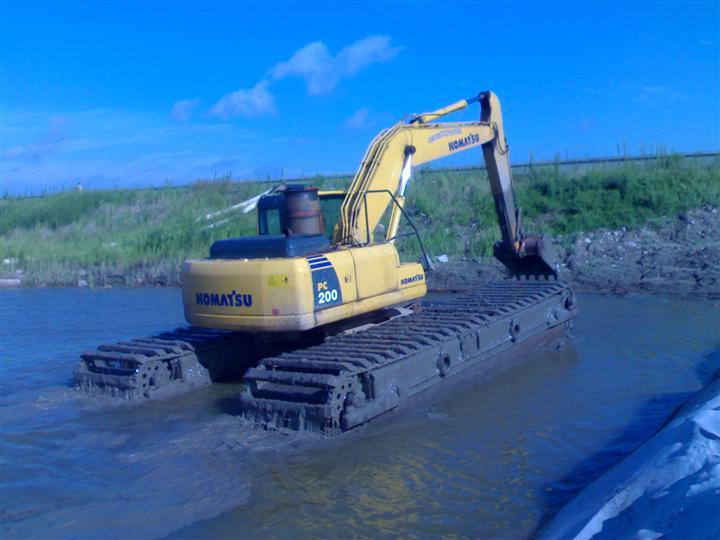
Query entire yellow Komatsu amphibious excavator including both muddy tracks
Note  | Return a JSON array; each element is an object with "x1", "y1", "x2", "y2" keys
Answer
[{"x1": 75, "y1": 92, "x2": 577, "y2": 434}]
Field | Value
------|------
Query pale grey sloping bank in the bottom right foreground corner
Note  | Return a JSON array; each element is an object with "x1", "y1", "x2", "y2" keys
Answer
[{"x1": 535, "y1": 369, "x2": 720, "y2": 540}]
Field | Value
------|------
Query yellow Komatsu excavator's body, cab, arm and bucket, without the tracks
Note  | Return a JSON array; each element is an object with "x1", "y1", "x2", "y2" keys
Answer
[{"x1": 182, "y1": 92, "x2": 556, "y2": 332}]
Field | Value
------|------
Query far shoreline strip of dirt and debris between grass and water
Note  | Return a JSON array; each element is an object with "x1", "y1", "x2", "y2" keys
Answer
[{"x1": 0, "y1": 206, "x2": 720, "y2": 300}]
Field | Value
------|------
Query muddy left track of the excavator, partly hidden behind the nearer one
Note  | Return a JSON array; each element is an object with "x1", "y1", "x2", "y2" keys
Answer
[{"x1": 74, "y1": 308, "x2": 409, "y2": 399}]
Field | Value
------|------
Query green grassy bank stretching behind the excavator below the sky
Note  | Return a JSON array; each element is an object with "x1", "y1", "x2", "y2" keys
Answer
[{"x1": 0, "y1": 156, "x2": 720, "y2": 284}]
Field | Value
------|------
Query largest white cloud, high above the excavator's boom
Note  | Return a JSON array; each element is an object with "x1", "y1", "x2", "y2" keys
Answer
[{"x1": 270, "y1": 36, "x2": 401, "y2": 95}]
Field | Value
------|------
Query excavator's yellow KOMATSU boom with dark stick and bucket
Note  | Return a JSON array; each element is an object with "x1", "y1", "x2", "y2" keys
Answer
[{"x1": 335, "y1": 92, "x2": 557, "y2": 277}]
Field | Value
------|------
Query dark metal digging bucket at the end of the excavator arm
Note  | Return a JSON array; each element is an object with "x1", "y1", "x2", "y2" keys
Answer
[{"x1": 494, "y1": 235, "x2": 558, "y2": 278}]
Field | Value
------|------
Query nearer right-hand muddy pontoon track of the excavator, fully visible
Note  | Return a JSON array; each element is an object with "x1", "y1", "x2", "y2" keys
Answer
[{"x1": 240, "y1": 281, "x2": 577, "y2": 434}]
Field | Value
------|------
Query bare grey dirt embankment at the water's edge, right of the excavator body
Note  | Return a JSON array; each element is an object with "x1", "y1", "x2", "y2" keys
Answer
[{"x1": 429, "y1": 207, "x2": 720, "y2": 299}]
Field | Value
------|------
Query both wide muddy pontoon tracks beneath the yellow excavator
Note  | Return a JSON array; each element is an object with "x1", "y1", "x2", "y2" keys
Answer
[{"x1": 75, "y1": 281, "x2": 577, "y2": 435}]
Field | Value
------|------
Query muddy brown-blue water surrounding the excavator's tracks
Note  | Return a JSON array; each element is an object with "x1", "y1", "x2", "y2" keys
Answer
[{"x1": 0, "y1": 289, "x2": 720, "y2": 538}]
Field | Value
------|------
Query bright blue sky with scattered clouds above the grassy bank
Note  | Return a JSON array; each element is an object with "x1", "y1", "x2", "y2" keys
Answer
[{"x1": 0, "y1": 0, "x2": 720, "y2": 193}]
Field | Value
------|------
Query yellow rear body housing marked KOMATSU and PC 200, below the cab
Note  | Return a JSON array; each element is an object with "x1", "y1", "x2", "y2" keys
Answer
[{"x1": 182, "y1": 243, "x2": 427, "y2": 332}]
